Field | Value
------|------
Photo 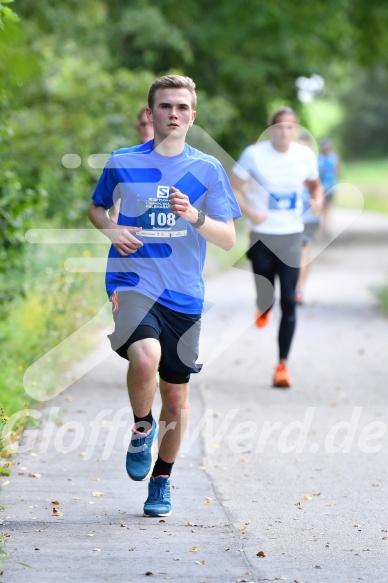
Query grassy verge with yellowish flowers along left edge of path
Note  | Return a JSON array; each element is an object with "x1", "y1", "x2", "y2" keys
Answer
[{"x1": 0, "y1": 238, "x2": 107, "y2": 453}]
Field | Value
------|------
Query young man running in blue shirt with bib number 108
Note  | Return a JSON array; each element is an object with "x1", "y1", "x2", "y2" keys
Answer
[{"x1": 89, "y1": 75, "x2": 241, "y2": 516}]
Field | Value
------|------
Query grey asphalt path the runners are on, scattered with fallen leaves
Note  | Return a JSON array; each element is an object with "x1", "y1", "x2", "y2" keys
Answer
[{"x1": 0, "y1": 212, "x2": 388, "y2": 583}]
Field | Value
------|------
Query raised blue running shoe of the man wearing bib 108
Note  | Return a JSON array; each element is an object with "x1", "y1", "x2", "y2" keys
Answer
[{"x1": 126, "y1": 420, "x2": 159, "y2": 482}]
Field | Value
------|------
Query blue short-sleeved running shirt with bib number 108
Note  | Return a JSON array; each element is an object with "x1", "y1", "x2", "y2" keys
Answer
[{"x1": 92, "y1": 140, "x2": 241, "y2": 314}]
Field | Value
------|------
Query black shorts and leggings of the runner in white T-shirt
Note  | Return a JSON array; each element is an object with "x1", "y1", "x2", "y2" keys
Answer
[{"x1": 247, "y1": 233, "x2": 302, "y2": 359}]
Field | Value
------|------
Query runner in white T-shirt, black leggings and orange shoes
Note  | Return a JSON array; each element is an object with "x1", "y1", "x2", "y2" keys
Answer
[{"x1": 231, "y1": 107, "x2": 323, "y2": 388}]
